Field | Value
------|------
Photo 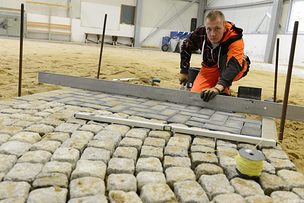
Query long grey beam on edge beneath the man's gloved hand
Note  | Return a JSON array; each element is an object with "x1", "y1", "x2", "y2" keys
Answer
[{"x1": 38, "y1": 72, "x2": 304, "y2": 121}]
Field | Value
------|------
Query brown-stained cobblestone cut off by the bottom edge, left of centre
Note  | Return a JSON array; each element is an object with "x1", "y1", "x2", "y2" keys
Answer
[{"x1": 109, "y1": 190, "x2": 142, "y2": 203}]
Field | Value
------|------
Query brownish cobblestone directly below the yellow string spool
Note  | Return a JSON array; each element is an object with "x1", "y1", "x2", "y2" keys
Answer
[{"x1": 230, "y1": 178, "x2": 264, "y2": 197}]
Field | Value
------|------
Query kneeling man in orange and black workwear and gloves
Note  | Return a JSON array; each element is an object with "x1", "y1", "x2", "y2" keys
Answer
[{"x1": 179, "y1": 11, "x2": 250, "y2": 102}]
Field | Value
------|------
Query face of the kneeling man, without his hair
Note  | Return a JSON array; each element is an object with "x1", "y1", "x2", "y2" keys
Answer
[{"x1": 205, "y1": 18, "x2": 225, "y2": 44}]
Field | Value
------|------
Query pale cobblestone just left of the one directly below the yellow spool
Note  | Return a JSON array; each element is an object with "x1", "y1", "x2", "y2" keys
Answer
[{"x1": 199, "y1": 174, "x2": 234, "y2": 199}]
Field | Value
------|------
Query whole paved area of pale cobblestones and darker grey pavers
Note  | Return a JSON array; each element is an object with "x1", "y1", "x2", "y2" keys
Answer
[{"x1": 0, "y1": 88, "x2": 304, "y2": 203}]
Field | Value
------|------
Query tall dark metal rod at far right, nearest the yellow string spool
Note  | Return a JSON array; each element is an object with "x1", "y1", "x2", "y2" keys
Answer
[{"x1": 279, "y1": 21, "x2": 299, "y2": 141}]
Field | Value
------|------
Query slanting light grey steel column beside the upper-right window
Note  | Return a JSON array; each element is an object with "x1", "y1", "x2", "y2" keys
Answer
[{"x1": 264, "y1": 0, "x2": 283, "y2": 63}]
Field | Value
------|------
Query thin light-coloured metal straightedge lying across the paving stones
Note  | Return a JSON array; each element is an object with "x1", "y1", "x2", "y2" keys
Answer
[{"x1": 74, "y1": 112, "x2": 277, "y2": 147}]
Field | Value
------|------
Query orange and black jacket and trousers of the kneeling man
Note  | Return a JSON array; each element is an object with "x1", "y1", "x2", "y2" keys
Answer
[{"x1": 180, "y1": 21, "x2": 250, "y2": 95}]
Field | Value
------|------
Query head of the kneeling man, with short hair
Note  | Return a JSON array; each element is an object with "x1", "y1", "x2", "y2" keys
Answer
[{"x1": 205, "y1": 10, "x2": 226, "y2": 44}]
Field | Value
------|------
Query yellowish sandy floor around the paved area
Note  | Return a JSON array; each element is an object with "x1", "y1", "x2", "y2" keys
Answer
[{"x1": 0, "y1": 38, "x2": 304, "y2": 173}]
